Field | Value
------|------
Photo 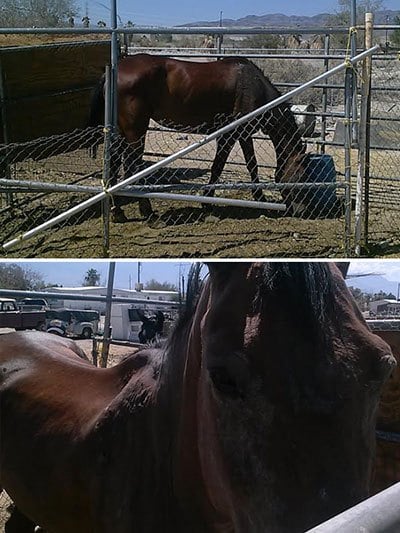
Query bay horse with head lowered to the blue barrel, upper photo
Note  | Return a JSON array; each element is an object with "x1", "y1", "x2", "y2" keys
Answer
[{"x1": 88, "y1": 54, "x2": 308, "y2": 220}]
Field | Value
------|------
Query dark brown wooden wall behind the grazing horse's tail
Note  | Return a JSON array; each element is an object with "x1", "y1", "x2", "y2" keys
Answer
[{"x1": 0, "y1": 41, "x2": 110, "y2": 143}]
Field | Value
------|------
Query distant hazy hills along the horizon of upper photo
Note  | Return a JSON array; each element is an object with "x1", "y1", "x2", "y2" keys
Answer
[{"x1": 182, "y1": 9, "x2": 400, "y2": 28}]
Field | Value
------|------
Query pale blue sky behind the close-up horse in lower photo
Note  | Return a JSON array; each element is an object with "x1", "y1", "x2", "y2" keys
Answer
[{"x1": 3, "y1": 259, "x2": 400, "y2": 296}]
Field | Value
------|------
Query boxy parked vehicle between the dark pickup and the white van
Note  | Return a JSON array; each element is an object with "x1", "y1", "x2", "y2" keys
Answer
[{"x1": 46, "y1": 308, "x2": 100, "y2": 339}]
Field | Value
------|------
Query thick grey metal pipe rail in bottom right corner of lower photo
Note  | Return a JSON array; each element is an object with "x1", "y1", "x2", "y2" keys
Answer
[{"x1": 307, "y1": 483, "x2": 400, "y2": 533}]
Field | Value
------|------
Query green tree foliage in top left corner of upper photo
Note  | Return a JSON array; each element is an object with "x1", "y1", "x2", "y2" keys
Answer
[{"x1": 0, "y1": 0, "x2": 78, "y2": 28}]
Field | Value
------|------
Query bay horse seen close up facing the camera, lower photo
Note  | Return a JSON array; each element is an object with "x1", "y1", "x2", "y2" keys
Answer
[{"x1": 0, "y1": 262, "x2": 394, "y2": 533}]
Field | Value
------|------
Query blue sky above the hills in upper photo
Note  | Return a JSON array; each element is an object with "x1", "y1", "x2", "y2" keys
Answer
[{"x1": 77, "y1": 0, "x2": 400, "y2": 26}]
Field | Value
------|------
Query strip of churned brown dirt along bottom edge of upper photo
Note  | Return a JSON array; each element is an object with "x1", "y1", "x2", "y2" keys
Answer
[{"x1": 0, "y1": 190, "x2": 400, "y2": 258}]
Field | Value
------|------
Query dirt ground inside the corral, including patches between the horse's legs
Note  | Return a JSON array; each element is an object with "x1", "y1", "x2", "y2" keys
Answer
[{"x1": 0, "y1": 139, "x2": 362, "y2": 258}]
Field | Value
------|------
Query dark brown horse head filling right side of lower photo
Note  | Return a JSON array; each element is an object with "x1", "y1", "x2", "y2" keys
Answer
[{"x1": 192, "y1": 263, "x2": 394, "y2": 532}]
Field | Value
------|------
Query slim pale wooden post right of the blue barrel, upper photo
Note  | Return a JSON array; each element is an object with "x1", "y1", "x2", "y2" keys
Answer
[{"x1": 354, "y1": 13, "x2": 374, "y2": 256}]
